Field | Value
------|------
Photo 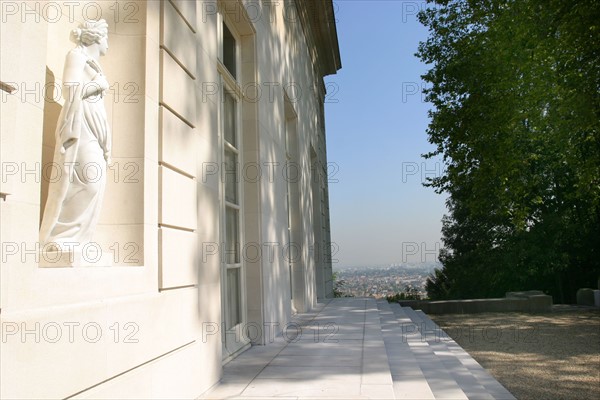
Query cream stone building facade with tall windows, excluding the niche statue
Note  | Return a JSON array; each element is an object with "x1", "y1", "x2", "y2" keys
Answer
[{"x1": 0, "y1": 0, "x2": 341, "y2": 399}]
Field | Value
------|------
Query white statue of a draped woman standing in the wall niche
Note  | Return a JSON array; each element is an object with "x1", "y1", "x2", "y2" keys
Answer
[{"x1": 40, "y1": 20, "x2": 111, "y2": 251}]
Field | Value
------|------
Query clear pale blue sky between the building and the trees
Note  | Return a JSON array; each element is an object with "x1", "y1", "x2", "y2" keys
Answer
[{"x1": 325, "y1": 0, "x2": 446, "y2": 269}]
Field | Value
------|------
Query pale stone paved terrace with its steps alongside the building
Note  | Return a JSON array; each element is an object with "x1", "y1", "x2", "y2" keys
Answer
[{"x1": 202, "y1": 298, "x2": 514, "y2": 400}]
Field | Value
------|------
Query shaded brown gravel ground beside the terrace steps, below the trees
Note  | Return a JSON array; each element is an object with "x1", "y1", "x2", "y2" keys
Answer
[{"x1": 429, "y1": 307, "x2": 600, "y2": 400}]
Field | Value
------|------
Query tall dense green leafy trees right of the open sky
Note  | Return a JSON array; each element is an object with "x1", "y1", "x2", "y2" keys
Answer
[{"x1": 417, "y1": 0, "x2": 600, "y2": 301}]
